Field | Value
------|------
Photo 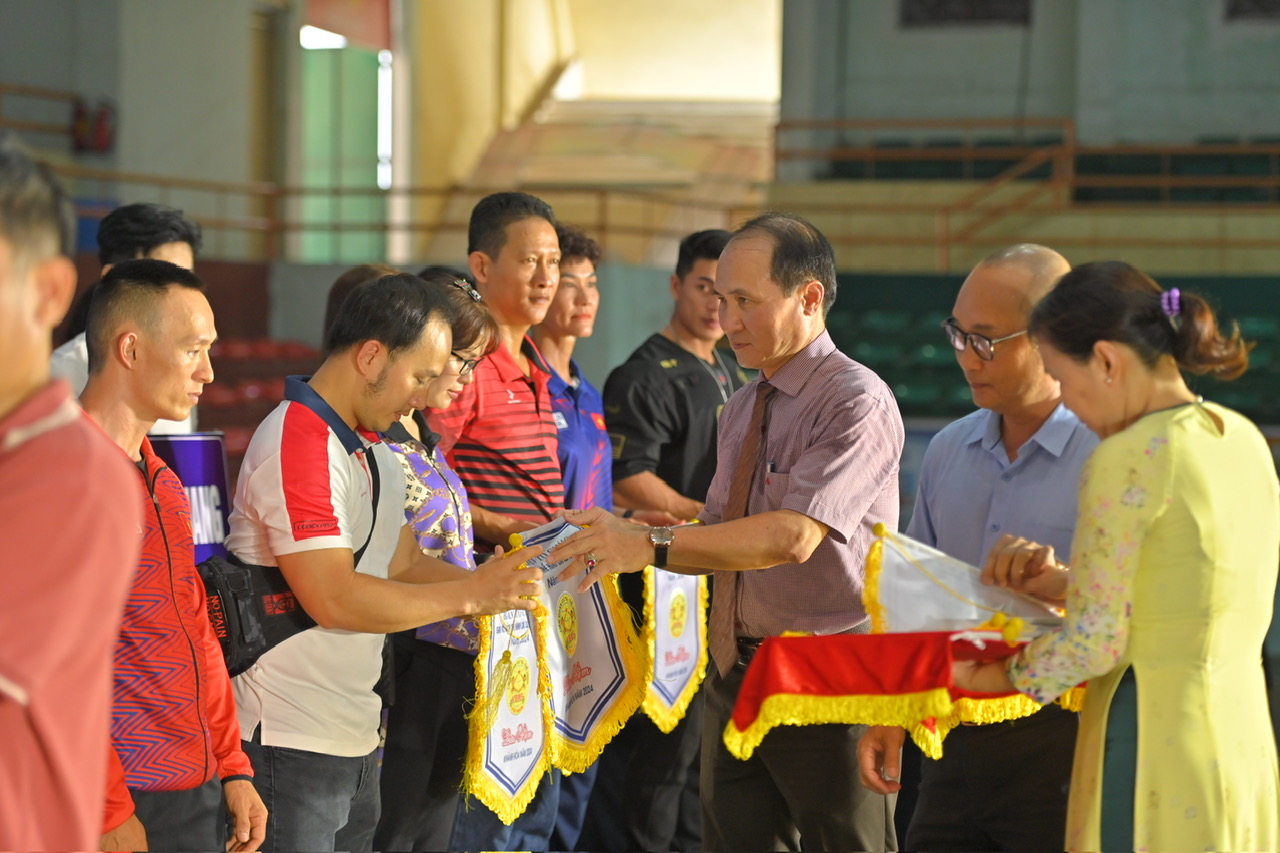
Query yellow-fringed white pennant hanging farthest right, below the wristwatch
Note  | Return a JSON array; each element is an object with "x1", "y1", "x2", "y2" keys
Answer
[{"x1": 644, "y1": 566, "x2": 707, "y2": 731}]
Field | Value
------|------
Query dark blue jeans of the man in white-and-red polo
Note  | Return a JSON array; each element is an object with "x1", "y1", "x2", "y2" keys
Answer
[{"x1": 241, "y1": 740, "x2": 379, "y2": 853}]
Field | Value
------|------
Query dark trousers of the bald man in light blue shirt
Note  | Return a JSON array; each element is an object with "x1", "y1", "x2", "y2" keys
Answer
[{"x1": 906, "y1": 704, "x2": 1078, "y2": 853}]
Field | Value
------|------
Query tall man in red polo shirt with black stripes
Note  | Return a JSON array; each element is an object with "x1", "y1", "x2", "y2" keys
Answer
[{"x1": 429, "y1": 192, "x2": 564, "y2": 850}]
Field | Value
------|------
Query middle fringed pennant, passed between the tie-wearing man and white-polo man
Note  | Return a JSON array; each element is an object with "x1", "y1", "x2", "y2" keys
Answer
[{"x1": 521, "y1": 519, "x2": 645, "y2": 774}]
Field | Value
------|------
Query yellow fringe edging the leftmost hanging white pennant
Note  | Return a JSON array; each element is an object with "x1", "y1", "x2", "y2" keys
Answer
[{"x1": 462, "y1": 534, "x2": 553, "y2": 826}]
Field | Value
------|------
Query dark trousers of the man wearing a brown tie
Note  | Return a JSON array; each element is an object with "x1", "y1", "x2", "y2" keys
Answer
[{"x1": 701, "y1": 665, "x2": 897, "y2": 850}]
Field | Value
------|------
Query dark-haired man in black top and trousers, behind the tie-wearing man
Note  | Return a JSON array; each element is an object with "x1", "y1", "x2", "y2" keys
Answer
[{"x1": 580, "y1": 231, "x2": 749, "y2": 850}]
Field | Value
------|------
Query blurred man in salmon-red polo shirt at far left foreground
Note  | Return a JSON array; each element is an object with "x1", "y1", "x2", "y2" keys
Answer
[{"x1": 0, "y1": 141, "x2": 146, "y2": 850}]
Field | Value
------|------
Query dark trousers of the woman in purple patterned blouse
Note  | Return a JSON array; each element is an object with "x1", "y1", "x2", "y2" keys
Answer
[{"x1": 374, "y1": 634, "x2": 476, "y2": 850}]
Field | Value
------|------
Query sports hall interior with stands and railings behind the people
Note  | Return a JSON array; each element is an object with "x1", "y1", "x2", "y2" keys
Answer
[{"x1": 0, "y1": 0, "x2": 1280, "y2": 496}]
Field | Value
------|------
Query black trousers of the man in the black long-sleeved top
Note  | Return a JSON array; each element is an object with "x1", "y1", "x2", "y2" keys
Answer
[{"x1": 579, "y1": 690, "x2": 703, "y2": 853}]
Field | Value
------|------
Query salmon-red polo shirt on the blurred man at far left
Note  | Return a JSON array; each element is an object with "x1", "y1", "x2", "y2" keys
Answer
[{"x1": 0, "y1": 379, "x2": 142, "y2": 850}]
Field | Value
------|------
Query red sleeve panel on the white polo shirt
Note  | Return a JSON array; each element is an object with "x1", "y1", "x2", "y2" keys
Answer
[{"x1": 280, "y1": 402, "x2": 340, "y2": 540}]
